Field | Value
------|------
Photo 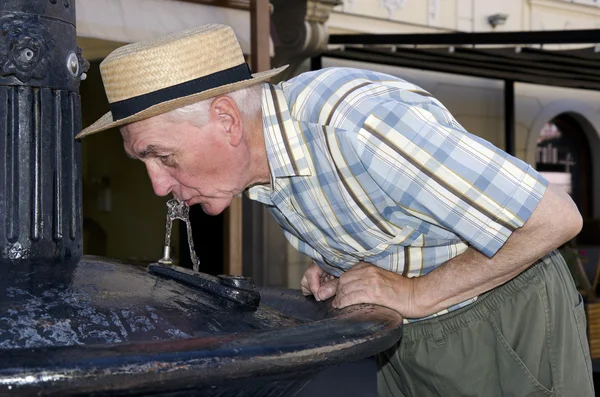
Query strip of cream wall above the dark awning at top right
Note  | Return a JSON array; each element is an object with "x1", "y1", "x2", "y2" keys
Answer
[{"x1": 328, "y1": 0, "x2": 600, "y2": 33}]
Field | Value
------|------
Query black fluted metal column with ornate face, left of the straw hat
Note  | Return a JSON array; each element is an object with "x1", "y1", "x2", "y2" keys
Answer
[{"x1": 0, "y1": 0, "x2": 87, "y2": 261}]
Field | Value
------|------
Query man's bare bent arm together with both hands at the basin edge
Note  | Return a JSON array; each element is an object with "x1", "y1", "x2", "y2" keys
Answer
[{"x1": 302, "y1": 185, "x2": 582, "y2": 318}]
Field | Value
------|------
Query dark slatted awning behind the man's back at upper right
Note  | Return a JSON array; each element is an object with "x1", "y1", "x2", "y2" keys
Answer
[{"x1": 323, "y1": 30, "x2": 600, "y2": 90}]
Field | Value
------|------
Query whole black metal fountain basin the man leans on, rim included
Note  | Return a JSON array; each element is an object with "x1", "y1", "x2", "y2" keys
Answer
[{"x1": 0, "y1": 257, "x2": 402, "y2": 396}]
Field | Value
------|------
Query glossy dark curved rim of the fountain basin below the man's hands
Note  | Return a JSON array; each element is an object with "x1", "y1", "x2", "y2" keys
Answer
[{"x1": 0, "y1": 291, "x2": 402, "y2": 395}]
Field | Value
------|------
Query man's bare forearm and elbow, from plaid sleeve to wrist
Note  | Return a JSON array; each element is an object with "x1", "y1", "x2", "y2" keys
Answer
[{"x1": 413, "y1": 186, "x2": 581, "y2": 314}]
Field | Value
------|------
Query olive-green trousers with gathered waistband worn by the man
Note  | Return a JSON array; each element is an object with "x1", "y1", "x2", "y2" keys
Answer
[{"x1": 377, "y1": 252, "x2": 594, "y2": 397}]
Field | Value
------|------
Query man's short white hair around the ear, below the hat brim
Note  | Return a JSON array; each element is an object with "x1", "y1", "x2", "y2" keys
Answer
[{"x1": 165, "y1": 84, "x2": 262, "y2": 127}]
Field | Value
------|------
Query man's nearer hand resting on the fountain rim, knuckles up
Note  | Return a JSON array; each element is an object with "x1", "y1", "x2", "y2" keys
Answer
[{"x1": 332, "y1": 262, "x2": 420, "y2": 318}]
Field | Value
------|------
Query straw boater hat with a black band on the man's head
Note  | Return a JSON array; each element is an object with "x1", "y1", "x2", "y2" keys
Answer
[{"x1": 75, "y1": 24, "x2": 287, "y2": 138}]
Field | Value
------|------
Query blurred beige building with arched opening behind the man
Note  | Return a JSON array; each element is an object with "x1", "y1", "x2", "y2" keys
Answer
[{"x1": 76, "y1": 0, "x2": 600, "y2": 288}]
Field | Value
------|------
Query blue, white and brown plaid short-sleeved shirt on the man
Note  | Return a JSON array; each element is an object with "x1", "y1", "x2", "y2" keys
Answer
[{"x1": 248, "y1": 68, "x2": 547, "y2": 314}]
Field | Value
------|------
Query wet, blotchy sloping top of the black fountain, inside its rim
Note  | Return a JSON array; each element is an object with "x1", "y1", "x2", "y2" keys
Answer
[{"x1": 0, "y1": 257, "x2": 298, "y2": 349}]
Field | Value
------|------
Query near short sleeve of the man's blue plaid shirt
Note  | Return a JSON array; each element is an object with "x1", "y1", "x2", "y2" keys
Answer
[{"x1": 357, "y1": 94, "x2": 548, "y2": 257}]
